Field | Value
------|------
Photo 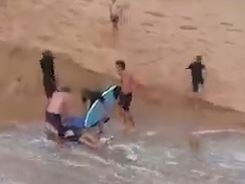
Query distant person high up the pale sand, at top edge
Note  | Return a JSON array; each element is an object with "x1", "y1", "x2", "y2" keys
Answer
[{"x1": 109, "y1": 0, "x2": 122, "y2": 30}]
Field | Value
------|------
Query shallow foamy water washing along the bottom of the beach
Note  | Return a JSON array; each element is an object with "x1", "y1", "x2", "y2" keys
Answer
[{"x1": 0, "y1": 125, "x2": 245, "y2": 184}]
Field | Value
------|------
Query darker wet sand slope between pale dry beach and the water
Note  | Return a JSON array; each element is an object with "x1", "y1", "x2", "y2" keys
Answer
[{"x1": 0, "y1": 42, "x2": 245, "y2": 136}]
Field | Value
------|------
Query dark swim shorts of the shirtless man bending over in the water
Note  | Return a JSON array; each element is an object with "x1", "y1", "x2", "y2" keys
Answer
[{"x1": 45, "y1": 111, "x2": 64, "y2": 137}]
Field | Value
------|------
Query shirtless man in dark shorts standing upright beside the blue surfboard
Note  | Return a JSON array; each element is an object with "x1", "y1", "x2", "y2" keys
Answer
[{"x1": 115, "y1": 60, "x2": 140, "y2": 130}]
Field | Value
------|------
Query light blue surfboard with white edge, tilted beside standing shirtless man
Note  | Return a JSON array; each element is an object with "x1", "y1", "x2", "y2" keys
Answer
[{"x1": 84, "y1": 85, "x2": 117, "y2": 128}]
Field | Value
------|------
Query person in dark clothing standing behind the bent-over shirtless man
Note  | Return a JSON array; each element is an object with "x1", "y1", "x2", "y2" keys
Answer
[{"x1": 40, "y1": 50, "x2": 56, "y2": 99}]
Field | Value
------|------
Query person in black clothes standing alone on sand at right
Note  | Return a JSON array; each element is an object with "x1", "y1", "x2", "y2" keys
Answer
[{"x1": 186, "y1": 55, "x2": 206, "y2": 93}]
